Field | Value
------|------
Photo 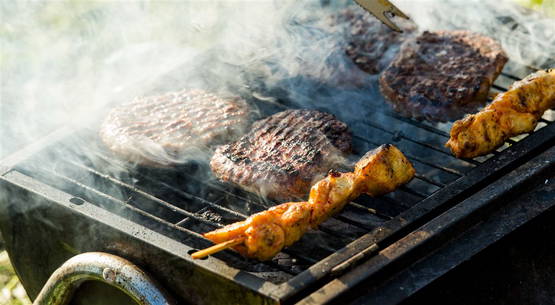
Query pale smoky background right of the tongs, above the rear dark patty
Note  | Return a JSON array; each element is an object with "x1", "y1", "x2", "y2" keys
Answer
[{"x1": 396, "y1": 0, "x2": 555, "y2": 68}]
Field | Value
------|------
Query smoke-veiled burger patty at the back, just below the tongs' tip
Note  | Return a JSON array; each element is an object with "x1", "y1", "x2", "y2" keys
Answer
[{"x1": 332, "y1": 6, "x2": 416, "y2": 74}]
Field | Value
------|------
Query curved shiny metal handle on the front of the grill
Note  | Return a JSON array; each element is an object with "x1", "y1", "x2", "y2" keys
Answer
[{"x1": 33, "y1": 252, "x2": 176, "y2": 305}]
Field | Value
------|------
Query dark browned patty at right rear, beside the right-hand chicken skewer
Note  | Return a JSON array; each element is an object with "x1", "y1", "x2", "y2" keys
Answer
[{"x1": 380, "y1": 31, "x2": 507, "y2": 121}]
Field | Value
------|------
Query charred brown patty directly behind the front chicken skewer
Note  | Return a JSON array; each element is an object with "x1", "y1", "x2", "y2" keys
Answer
[{"x1": 210, "y1": 110, "x2": 351, "y2": 199}]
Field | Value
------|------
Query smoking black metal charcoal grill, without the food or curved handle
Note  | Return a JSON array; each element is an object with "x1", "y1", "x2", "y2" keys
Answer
[{"x1": 0, "y1": 62, "x2": 555, "y2": 304}]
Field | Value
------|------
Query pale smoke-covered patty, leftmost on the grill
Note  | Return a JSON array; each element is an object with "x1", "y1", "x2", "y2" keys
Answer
[{"x1": 100, "y1": 90, "x2": 250, "y2": 167}]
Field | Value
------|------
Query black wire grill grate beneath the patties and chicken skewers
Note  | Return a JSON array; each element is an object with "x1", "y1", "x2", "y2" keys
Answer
[{"x1": 10, "y1": 61, "x2": 555, "y2": 284}]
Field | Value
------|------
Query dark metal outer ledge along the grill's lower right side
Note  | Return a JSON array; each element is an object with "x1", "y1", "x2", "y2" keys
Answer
[{"x1": 299, "y1": 147, "x2": 555, "y2": 305}]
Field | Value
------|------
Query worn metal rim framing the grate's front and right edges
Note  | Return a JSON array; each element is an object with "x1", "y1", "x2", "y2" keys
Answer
[{"x1": 0, "y1": 65, "x2": 555, "y2": 304}]
